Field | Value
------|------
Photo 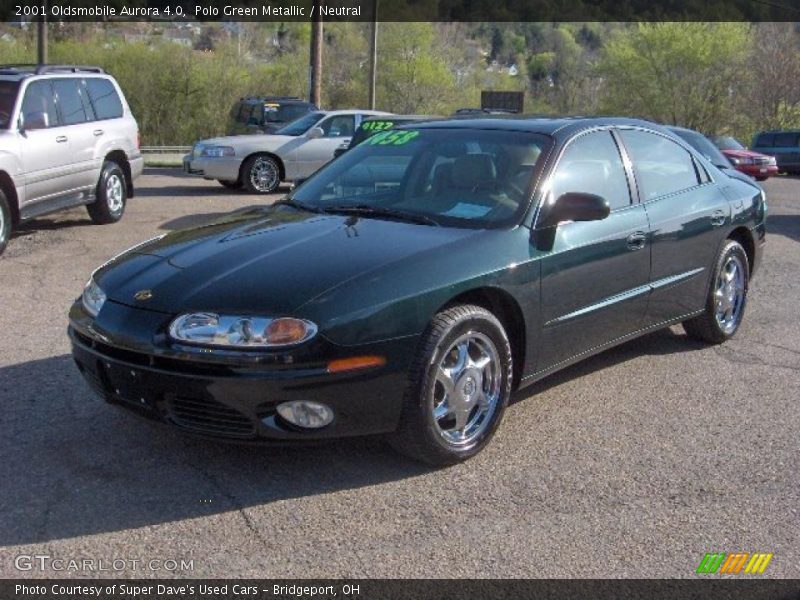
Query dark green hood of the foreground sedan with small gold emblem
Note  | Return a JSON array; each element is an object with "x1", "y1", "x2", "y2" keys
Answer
[{"x1": 95, "y1": 207, "x2": 478, "y2": 316}]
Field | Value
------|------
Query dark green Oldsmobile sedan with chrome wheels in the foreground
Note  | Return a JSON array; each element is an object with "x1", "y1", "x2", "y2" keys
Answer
[{"x1": 70, "y1": 118, "x2": 766, "y2": 464}]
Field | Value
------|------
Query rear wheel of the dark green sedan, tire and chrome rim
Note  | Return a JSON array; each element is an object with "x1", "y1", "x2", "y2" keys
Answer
[{"x1": 683, "y1": 240, "x2": 750, "y2": 344}]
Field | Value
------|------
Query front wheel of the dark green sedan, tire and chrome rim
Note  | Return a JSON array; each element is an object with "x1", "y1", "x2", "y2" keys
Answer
[{"x1": 389, "y1": 305, "x2": 512, "y2": 467}]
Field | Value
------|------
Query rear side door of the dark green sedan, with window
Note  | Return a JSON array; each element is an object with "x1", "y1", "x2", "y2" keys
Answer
[{"x1": 620, "y1": 129, "x2": 730, "y2": 326}]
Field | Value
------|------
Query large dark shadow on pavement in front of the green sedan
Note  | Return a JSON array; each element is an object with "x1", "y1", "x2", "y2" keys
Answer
[{"x1": 0, "y1": 355, "x2": 431, "y2": 546}]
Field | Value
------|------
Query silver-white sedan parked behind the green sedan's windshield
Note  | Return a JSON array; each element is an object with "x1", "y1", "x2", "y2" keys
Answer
[{"x1": 183, "y1": 110, "x2": 389, "y2": 194}]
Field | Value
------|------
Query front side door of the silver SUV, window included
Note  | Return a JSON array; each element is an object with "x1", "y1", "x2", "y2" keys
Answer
[{"x1": 20, "y1": 79, "x2": 70, "y2": 209}]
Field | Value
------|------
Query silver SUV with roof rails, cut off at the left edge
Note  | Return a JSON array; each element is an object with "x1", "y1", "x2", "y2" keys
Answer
[{"x1": 0, "y1": 65, "x2": 144, "y2": 253}]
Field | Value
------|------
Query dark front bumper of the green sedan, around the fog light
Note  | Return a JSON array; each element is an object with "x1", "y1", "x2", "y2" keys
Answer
[{"x1": 68, "y1": 302, "x2": 416, "y2": 443}]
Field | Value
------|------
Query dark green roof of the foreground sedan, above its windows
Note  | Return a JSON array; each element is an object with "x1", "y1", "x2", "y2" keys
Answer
[{"x1": 410, "y1": 115, "x2": 666, "y2": 136}]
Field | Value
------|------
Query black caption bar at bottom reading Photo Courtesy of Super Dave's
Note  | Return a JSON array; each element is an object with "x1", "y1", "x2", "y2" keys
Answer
[{"x1": 0, "y1": 579, "x2": 800, "y2": 600}]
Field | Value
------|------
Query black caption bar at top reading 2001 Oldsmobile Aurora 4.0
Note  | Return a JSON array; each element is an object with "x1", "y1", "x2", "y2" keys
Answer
[{"x1": 0, "y1": 0, "x2": 800, "y2": 22}]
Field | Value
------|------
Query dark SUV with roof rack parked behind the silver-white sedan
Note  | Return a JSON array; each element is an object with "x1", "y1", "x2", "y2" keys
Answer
[{"x1": 229, "y1": 96, "x2": 319, "y2": 135}]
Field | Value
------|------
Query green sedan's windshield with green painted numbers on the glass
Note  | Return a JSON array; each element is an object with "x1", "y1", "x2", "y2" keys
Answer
[{"x1": 288, "y1": 128, "x2": 551, "y2": 228}]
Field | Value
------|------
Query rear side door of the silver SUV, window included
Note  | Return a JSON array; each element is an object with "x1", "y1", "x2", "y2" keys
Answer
[{"x1": 53, "y1": 77, "x2": 98, "y2": 191}]
